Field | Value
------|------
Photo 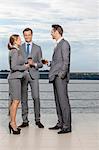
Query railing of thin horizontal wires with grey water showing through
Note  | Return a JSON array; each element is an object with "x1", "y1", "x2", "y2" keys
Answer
[{"x1": 0, "y1": 79, "x2": 99, "y2": 113}]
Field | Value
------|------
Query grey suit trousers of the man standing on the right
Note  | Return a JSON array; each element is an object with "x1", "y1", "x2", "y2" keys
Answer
[{"x1": 53, "y1": 76, "x2": 71, "y2": 129}]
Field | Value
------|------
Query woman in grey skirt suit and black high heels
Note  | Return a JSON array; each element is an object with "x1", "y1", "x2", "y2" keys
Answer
[{"x1": 8, "y1": 34, "x2": 29, "y2": 134}]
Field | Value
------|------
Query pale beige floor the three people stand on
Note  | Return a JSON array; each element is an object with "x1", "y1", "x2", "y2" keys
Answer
[{"x1": 0, "y1": 110, "x2": 99, "y2": 150}]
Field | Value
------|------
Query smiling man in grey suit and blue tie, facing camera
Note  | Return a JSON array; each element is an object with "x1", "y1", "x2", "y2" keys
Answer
[{"x1": 19, "y1": 28, "x2": 44, "y2": 128}]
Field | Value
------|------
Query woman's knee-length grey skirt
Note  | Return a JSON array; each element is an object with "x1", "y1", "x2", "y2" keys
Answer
[{"x1": 8, "y1": 79, "x2": 21, "y2": 101}]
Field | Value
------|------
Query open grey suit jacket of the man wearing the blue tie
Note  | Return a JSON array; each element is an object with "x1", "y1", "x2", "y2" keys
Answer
[{"x1": 21, "y1": 43, "x2": 43, "y2": 79}]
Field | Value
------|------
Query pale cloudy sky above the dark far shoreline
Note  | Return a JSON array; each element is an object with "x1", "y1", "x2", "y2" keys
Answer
[{"x1": 0, "y1": 0, "x2": 99, "y2": 72}]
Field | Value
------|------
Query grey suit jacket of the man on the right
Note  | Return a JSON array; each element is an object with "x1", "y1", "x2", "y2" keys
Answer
[{"x1": 49, "y1": 39, "x2": 70, "y2": 82}]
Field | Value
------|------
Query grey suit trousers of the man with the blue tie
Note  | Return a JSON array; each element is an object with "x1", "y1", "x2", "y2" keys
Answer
[{"x1": 21, "y1": 73, "x2": 40, "y2": 122}]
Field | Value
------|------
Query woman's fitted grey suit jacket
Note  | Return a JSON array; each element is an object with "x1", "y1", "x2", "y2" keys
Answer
[{"x1": 8, "y1": 48, "x2": 26, "y2": 79}]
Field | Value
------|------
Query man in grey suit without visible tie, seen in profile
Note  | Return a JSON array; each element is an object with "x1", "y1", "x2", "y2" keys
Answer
[{"x1": 49, "y1": 25, "x2": 71, "y2": 134}]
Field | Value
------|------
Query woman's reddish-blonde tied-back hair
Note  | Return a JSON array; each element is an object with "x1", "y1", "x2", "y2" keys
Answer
[{"x1": 8, "y1": 34, "x2": 19, "y2": 50}]
